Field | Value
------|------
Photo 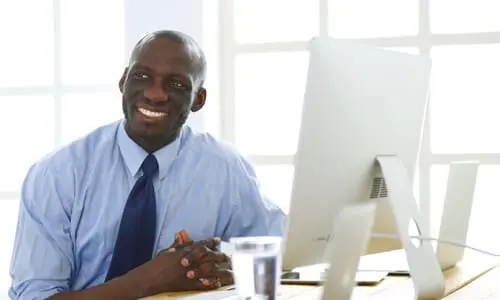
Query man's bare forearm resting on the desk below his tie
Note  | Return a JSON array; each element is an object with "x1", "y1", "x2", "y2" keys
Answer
[{"x1": 50, "y1": 272, "x2": 151, "y2": 300}]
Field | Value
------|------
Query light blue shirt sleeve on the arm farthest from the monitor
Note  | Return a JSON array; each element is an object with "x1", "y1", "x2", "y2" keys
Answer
[{"x1": 9, "y1": 165, "x2": 74, "y2": 300}]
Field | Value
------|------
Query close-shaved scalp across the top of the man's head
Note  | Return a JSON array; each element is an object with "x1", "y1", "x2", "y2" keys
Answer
[{"x1": 129, "y1": 30, "x2": 207, "y2": 86}]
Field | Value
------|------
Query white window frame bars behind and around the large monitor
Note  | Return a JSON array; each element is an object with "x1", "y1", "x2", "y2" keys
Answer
[{"x1": 219, "y1": 0, "x2": 500, "y2": 232}]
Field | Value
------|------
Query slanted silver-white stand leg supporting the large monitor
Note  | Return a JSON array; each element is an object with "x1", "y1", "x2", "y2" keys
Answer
[{"x1": 376, "y1": 155, "x2": 445, "y2": 299}]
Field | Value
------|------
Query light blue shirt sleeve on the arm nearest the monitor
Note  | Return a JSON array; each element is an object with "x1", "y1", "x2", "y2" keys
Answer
[{"x1": 222, "y1": 159, "x2": 286, "y2": 241}]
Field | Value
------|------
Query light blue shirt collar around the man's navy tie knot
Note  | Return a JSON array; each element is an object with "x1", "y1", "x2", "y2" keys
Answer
[{"x1": 118, "y1": 120, "x2": 182, "y2": 179}]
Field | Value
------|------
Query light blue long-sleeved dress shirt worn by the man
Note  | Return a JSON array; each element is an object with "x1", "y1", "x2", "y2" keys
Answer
[{"x1": 9, "y1": 121, "x2": 285, "y2": 300}]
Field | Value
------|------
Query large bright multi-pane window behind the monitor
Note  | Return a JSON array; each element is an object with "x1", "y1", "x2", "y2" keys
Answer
[{"x1": 220, "y1": 0, "x2": 500, "y2": 253}]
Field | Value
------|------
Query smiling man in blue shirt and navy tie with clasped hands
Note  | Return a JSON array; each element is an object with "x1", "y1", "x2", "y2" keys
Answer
[{"x1": 9, "y1": 31, "x2": 285, "y2": 300}]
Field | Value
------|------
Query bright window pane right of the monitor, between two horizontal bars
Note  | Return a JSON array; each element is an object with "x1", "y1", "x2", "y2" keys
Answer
[{"x1": 431, "y1": 44, "x2": 500, "y2": 153}]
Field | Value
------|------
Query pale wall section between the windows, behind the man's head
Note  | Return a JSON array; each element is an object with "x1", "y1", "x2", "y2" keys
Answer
[{"x1": 125, "y1": 0, "x2": 218, "y2": 131}]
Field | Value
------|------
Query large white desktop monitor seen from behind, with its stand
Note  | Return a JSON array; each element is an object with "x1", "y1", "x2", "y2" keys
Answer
[{"x1": 283, "y1": 38, "x2": 443, "y2": 295}]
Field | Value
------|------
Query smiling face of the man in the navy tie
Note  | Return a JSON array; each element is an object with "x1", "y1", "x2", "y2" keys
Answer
[{"x1": 120, "y1": 38, "x2": 205, "y2": 145}]
